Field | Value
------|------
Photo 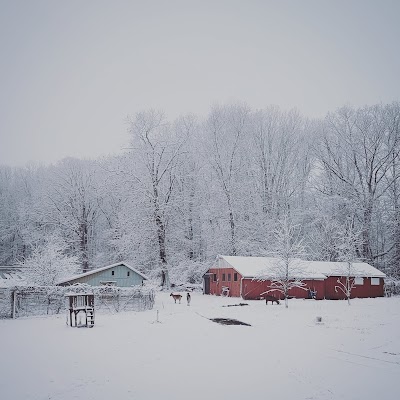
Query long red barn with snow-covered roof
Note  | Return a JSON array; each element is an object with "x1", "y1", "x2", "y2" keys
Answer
[{"x1": 203, "y1": 256, "x2": 386, "y2": 300}]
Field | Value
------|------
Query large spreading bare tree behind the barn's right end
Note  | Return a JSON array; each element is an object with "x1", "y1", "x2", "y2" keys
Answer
[{"x1": 318, "y1": 104, "x2": 400, "y2": 261}]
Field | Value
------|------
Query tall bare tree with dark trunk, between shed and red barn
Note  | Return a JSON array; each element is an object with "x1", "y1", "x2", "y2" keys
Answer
[{"x1": 128, "y1": 110, "x2": 187, "y2": 289}]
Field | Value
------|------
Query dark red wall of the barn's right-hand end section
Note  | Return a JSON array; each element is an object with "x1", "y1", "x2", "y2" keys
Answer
[{"x1": 325, "y1": 276, "x2": 384, "y2": 300}]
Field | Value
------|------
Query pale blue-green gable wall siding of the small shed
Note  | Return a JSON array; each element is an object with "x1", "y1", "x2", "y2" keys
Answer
[{"x1": 62, "y1": 265, "x2": 143, "y2": 287}]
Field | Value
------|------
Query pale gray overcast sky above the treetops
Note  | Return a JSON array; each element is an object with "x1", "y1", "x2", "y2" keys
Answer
[{"x1": 0, "y1": 0, "x2": 400, "y2": 165}]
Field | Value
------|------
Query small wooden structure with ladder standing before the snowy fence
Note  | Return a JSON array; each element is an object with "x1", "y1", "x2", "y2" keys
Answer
[{"x1": 65, "y1": 293, "x2": 94, "y2": 328}]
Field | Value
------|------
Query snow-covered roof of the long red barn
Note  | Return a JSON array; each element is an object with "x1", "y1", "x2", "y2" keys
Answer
[{"x1": 214, "y1": 255, "x2": 386, "y2": 279}]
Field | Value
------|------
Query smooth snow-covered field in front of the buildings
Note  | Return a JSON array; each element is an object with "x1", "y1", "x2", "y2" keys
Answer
[{"x1": 0, "y1": 293, "x2": 400, "y2": 400}]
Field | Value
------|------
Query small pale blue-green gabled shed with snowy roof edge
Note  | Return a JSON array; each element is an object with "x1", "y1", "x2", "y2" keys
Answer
[{"x1": 58, "y1": 261, "x2": 148, "y2": 287}]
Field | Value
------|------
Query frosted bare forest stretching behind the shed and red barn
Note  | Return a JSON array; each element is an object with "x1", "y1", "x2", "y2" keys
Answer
[{"x1": 0, "y1": 102, "x2": 400, "y2": 284}]
